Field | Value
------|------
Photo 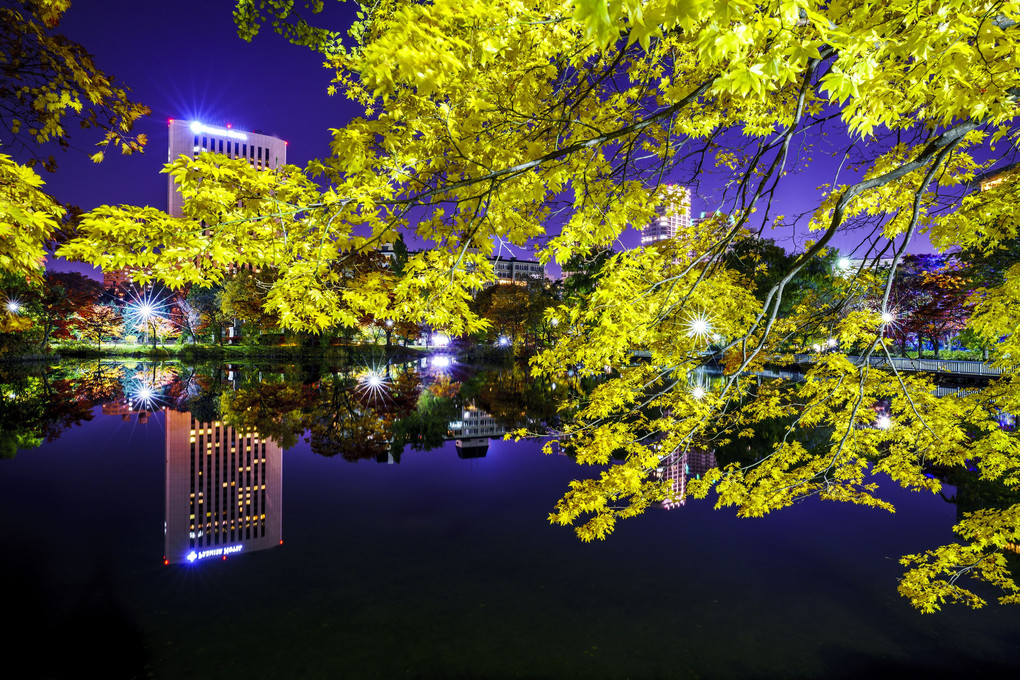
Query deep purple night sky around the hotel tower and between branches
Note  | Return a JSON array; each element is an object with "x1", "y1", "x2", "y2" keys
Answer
[{"x1": 20, "y1": 0, "x2": 928, "y2": 276}]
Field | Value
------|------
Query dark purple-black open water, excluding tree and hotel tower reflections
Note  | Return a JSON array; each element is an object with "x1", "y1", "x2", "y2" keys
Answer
[{"x1": 0, "y1": 358, "x2": 1020, "y2": 678}]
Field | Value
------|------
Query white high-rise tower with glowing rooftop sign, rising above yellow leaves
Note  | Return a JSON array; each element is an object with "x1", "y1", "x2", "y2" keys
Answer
[{"x1": 166, "y1": 119, "x2": 287, "y2": 217}]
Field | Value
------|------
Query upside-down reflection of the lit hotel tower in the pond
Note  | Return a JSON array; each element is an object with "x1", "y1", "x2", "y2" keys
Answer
[{"x1": 164, "y1": 411, "x2": 284, "y2": 563}]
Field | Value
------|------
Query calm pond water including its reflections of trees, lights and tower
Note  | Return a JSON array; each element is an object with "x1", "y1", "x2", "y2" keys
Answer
[{"x1": 0, "y1": 363, "x2": 1020, "y2": 678}]
